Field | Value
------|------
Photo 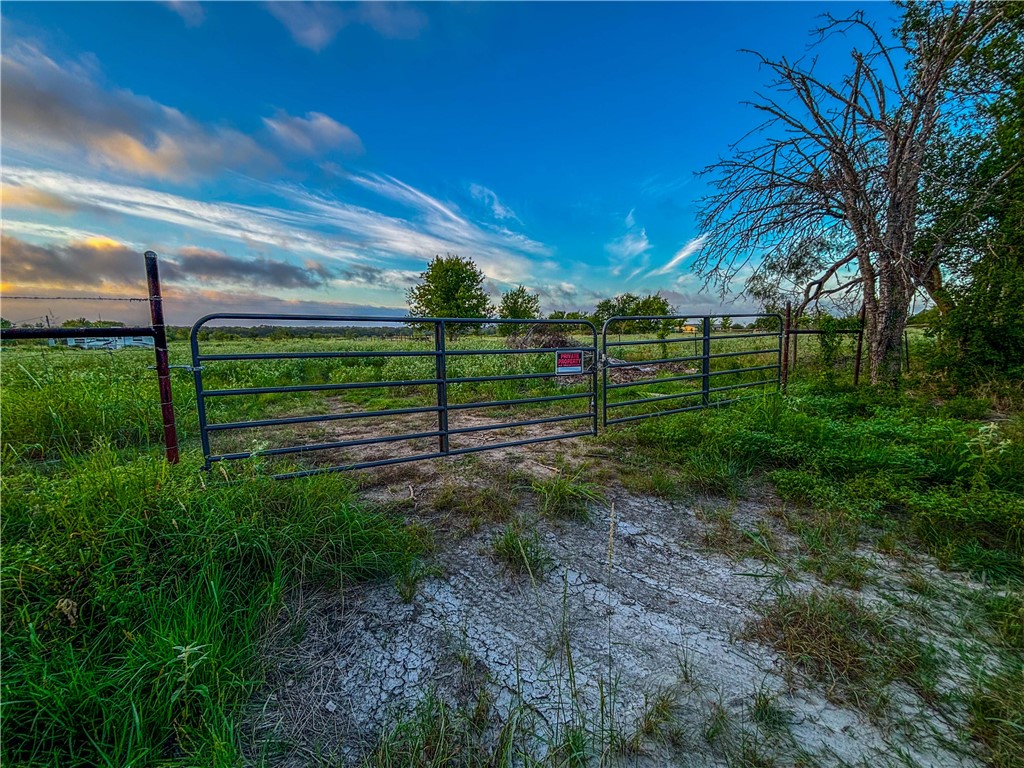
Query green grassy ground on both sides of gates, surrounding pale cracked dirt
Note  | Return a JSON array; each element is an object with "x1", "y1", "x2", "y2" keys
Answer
[{"x1": 0, "y1": 337, "x2": 1024, "y2": 766}]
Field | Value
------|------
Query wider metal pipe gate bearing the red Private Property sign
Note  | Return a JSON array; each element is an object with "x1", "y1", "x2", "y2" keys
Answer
[{"x1": 190, "y1": 312, "x2": 598, "y2": 478}]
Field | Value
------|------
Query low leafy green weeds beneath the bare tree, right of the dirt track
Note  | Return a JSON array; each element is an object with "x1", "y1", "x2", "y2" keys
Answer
[{"x1": 618, "y1": 386, "x2": 1024, "y2": 585}]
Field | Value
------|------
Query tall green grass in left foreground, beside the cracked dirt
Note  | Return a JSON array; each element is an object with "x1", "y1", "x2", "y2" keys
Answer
[{"x1": 0, "y1": 446, "x2": 415, "y2": 766}]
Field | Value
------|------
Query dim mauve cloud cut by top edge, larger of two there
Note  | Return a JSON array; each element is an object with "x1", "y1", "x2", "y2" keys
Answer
[{"x1": 266, "y1": 2, "x2": 427, "y2": 53}]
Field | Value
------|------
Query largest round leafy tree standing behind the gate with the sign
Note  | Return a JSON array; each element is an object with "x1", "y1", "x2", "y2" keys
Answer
[{"x1": 407, "y1": 254, "x2": 494, "y2": 339}]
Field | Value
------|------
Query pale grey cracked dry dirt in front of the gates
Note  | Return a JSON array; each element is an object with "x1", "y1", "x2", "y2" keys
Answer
[{"x1": 248, "y1": 455, "x2": 977, "y2": 766}]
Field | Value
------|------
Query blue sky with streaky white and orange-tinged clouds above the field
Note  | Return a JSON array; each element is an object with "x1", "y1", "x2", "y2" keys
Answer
[{"x1": 0, "y1": 2, "x2": 896, "y2": 323}]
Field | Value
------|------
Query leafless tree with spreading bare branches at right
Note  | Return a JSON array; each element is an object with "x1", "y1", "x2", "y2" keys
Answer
[{"x1": 697, "y1": 3, "x2": 999, "y2": 383}]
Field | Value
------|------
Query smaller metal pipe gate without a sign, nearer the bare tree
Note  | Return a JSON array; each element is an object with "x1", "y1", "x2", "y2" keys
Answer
[{"x1": 601, "y1": 314, "x2": 784, "y2": 426}]
